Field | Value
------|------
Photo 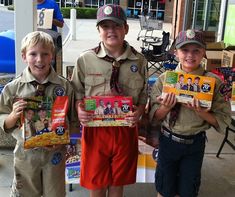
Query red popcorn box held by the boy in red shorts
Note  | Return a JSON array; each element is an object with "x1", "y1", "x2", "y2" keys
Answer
[{"x1": 84, "y1": 96, "x2": 132, "y2": 127}]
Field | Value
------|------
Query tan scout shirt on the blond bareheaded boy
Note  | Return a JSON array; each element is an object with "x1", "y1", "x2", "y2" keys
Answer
[{"x1": 0, "y1": 67, "x2": 78, "y2": 140}]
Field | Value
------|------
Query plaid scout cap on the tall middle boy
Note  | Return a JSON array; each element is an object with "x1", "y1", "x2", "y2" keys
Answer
[{"x1": 96, "y1": 4, "x2": 126, "y2": 25}]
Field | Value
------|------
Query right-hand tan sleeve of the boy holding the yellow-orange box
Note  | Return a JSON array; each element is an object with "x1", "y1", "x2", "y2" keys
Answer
[{"x1": 211, "y1": 78, "x2": 231, "y2": 133}]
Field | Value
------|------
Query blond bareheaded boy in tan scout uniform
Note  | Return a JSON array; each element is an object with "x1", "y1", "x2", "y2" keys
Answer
[{"x1": 0, "y1": 31, "x2": 76, "y2": 197}]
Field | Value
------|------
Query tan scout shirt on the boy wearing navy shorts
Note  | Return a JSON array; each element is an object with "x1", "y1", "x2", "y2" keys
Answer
[{"x1": 149, "y1": 64, "x2": 231, "y2": 135}]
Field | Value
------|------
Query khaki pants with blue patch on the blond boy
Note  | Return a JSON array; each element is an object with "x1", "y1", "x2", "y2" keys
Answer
[{"x1": 11, "y1": 144, "x2": 65, "y2": 197}]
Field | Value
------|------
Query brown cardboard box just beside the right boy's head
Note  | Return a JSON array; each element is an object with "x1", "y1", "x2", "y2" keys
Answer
[{"x1": 201, "y1": 51, "x2": 222, "y2": 71}]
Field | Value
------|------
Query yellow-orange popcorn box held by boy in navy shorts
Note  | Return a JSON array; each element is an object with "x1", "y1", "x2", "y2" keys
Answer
[{"x1": 163, "y1": 71, "x2": 215, "y2": 108}]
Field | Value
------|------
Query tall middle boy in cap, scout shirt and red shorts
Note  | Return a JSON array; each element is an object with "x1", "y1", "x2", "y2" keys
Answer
[{"x1": 72, "y1": 5, "x2": 147, "y2": 197}]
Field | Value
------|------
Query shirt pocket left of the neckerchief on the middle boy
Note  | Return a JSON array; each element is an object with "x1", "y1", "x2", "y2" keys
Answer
[{"x1": 85, "y1": 76, "x2": 106, "y2": 96}]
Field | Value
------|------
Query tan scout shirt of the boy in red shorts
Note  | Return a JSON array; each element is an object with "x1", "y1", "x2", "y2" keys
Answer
[{"x1": 72, "y1": 43, "x2": 147, "y2": 105}]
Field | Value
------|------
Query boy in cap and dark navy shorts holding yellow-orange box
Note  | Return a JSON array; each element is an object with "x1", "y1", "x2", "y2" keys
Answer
[{"x1": 150, "y1": 29, "x2": 231, "y2": 197}]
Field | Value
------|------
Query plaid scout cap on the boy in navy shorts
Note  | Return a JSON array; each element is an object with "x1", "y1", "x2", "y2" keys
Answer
[{"x1": 175, "y1": 29, "x2": 206, "y2": 49}]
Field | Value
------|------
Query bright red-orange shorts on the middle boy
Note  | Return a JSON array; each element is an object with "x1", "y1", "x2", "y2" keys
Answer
[{"x1": 80, "y1": 127, "x2": 138, "y2": 190}]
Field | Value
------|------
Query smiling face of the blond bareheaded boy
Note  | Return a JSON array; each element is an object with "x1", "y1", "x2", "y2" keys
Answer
[{"x1": 22, "y1": 44, "x2": 53, "y2": 82}]
